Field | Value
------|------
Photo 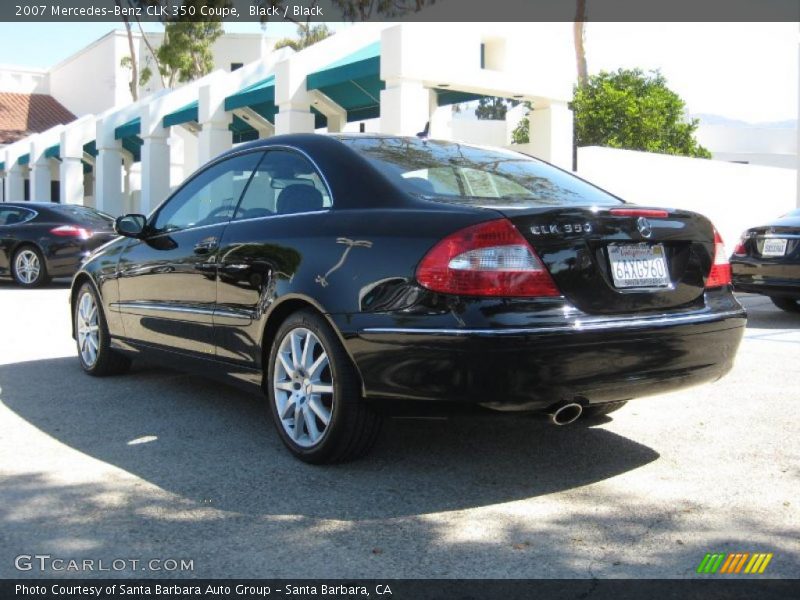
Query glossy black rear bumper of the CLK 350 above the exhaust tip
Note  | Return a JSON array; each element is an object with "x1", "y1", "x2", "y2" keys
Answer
[{"x1": 338, "y1": 302, "x2": 746, "y2": 410}]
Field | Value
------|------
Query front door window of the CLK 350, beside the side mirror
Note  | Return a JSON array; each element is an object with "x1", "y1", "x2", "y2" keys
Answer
[{"x1": 152, "y1": 152, "x2": 263, "y2": 232}]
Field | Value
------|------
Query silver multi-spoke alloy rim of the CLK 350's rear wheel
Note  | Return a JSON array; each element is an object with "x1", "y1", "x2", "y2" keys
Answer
[{"x1": 272, "y1": 327, "x2": 335, "y2": 448}]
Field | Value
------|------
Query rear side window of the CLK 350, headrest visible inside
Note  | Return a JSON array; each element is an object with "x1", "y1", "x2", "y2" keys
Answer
[{"x1": 234, "y1": 149, "x2": 331, "y2": 220}]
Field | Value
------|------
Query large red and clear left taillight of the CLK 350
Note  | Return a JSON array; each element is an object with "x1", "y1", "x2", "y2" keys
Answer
[{"x1": 417, "y1": 219, "x2": 560, "y2": 297}]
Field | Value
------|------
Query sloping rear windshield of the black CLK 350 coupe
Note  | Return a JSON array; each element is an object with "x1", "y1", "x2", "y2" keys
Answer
[{"x1": 340, "y1": 137, "x2": 621, "y2": 208}]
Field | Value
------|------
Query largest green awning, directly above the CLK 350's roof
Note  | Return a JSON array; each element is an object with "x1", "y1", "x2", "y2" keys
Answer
[{"x1": 306, "y1": 42, "x2": 386, "y2": 121}]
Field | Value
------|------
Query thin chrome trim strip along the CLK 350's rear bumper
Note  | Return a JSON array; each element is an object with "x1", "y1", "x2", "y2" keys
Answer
[{"x1": 360, "y1": 310, "x2": 747, "y2": 336}]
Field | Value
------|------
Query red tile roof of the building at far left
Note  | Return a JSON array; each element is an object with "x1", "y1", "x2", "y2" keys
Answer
[{"x1": 0, "y1": 92, "x2": 76, "y2": 144}]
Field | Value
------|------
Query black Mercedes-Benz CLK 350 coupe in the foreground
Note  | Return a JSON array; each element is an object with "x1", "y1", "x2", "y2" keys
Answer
[{"x1": 72, "y1": 135, "x2": 745, "y2": 463}]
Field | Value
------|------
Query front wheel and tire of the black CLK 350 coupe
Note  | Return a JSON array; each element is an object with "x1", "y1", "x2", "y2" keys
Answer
[{"x1": 72, "y1": 283, "x2": 131, "y2": 377}]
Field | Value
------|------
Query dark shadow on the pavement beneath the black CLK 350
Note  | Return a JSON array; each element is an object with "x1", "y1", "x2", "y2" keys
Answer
[{"x1": 0, "y1": 358, "x2": 658, "y2": 521}]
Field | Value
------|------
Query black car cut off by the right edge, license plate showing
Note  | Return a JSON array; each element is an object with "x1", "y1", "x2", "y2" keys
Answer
[{"x1": 731, "y1": 208, "x2": 800, "y2": 313}]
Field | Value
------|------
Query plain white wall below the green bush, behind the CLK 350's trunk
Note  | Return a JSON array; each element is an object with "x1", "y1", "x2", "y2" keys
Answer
[{"x1": 577, "y1": 147, "x2": 796, "y2": 251}]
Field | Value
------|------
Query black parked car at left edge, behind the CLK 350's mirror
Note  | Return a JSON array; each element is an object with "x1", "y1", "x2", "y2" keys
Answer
[{"x1": 0, "y1": 202, "x2": 116, "y2": 287}]
